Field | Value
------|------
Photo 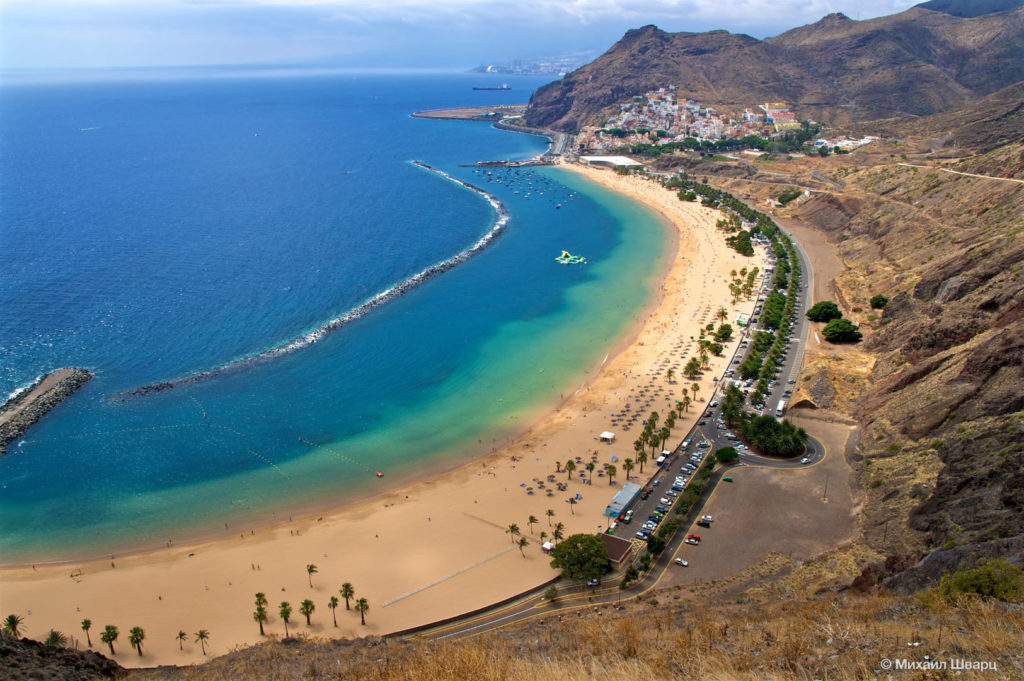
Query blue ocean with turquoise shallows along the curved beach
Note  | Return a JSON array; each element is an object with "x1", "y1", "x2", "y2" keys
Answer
[{"x1": 0, "y1": 71, "x2": 667, "y2": 562}]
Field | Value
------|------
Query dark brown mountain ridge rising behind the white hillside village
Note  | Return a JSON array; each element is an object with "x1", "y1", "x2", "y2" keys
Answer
[{"x1": 526, "y1": 2, "x2": 1024, "y2": 130}]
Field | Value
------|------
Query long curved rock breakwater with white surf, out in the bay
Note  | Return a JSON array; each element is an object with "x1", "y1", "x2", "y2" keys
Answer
[{"x1": 111, "y1": 161, "x2": 510, "y2": 401}]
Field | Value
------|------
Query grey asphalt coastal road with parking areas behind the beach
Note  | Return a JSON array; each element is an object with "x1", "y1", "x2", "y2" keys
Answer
[{"x1": 403, "y1": 199, "x2": 826, "y2": 640}]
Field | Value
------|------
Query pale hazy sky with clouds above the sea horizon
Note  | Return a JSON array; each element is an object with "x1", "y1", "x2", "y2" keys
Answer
[{"x1": 0, "y1": 0, "x2": 915, "y2": 69}]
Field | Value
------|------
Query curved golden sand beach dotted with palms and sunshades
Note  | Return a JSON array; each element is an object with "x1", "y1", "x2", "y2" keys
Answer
[{"x1": 0, "y1": 166, "x2": 763, "y2": 667}]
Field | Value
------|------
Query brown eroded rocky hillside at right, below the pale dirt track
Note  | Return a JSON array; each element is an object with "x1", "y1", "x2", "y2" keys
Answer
[{"x1": 796, "y1": 160, "x2": 1024, "y2": 553}]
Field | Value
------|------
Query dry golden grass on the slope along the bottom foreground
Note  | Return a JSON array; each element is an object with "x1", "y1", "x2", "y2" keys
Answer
[{"x1": 129, "y1": 594, "x2": 1024, "y2": 681}]
